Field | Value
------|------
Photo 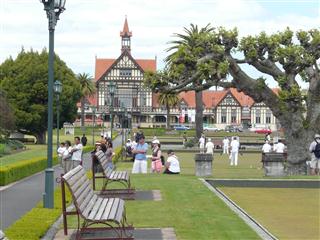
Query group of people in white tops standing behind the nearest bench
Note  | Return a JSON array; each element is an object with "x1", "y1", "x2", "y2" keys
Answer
[{"x1": 57, "y1": 137, "x2": 83, "y2": 173}]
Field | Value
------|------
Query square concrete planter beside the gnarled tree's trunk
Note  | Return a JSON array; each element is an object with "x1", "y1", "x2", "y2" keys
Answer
[{"x1": 262, "y1": 153, "x2": 286, "y2": 177}]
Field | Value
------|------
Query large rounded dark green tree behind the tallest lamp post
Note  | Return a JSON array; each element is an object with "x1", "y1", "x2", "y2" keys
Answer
[{"x1": 0, "y1": 49, "x2": 81, "y2": 144}]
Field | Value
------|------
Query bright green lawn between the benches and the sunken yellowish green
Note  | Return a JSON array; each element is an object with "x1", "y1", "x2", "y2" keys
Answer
[{"x1": 68, "y1": 173, "x2": 259, "y2": 240}]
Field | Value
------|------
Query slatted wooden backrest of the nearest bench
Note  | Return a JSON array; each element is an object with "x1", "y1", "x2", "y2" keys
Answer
[{"x1": 62, "y1": 165, "x2": 97, "y2": 218}]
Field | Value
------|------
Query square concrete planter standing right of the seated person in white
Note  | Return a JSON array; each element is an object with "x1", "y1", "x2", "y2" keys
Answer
[{"x1": 194, "y1": 153, "x2": 213, "y2": 177}]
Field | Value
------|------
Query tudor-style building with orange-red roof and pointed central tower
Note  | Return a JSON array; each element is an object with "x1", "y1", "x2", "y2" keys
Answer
[{"x1": 76, "y1": 19, "x2": 277, "y2": 130}]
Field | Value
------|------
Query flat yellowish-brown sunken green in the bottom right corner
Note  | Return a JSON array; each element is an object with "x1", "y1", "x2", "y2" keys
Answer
[{"x1": 220, "y1": 187, "x2": 320, "y2": 240}]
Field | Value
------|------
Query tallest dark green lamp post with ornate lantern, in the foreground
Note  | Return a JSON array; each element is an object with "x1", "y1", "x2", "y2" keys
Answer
[{"x1": 41, "y1": 0, "x2": 66, "y2": 208}]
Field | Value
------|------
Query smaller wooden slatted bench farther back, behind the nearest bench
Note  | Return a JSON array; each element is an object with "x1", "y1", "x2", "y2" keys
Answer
[{"x1": 92, "y1": 151, "x2": 135, "y2": 199}]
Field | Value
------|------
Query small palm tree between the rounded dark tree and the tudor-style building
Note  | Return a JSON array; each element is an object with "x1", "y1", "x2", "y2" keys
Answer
[{"x1": 77, "y1": 73, "x2": 96, "y2": 127}]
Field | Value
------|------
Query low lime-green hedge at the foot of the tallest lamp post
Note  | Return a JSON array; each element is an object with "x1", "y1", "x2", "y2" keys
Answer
[{"x1": 4, "y1": 147, "x2": 121, "y2": 240}]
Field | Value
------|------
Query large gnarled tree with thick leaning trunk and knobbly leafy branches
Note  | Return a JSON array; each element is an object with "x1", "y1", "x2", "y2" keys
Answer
[{"x1": 146, "y1": 25, "x2": 320, "y2": 174}]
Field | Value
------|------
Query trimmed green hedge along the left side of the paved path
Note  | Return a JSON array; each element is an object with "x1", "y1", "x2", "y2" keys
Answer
[{"x1": 0, "y1": 146, "x2": 92, "y2": 186}]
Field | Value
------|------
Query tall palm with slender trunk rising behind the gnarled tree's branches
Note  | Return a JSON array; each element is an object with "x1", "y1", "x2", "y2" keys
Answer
[{"x1": 166, "y1": 24, "x2": 213, "y2": 138}]
